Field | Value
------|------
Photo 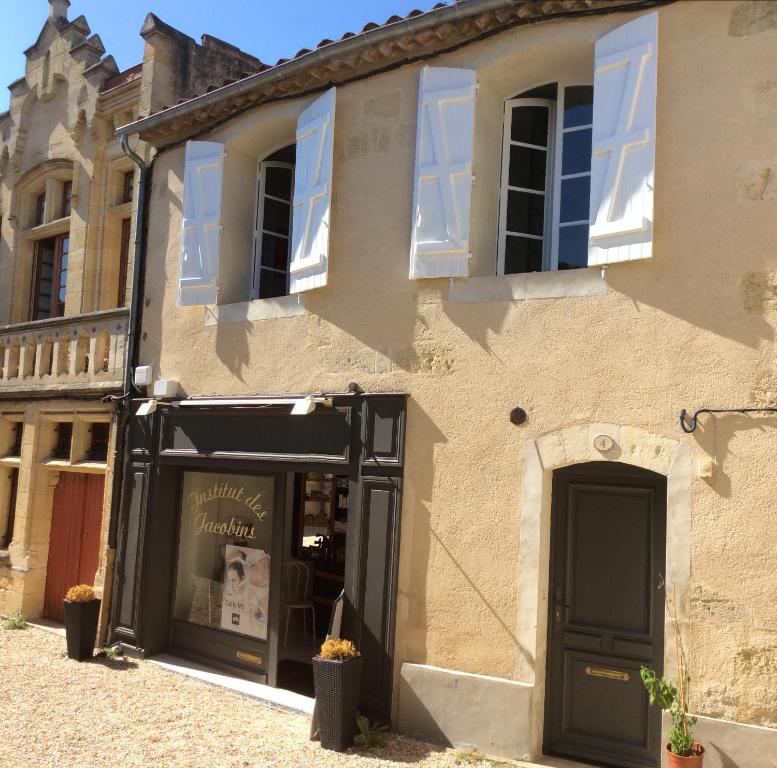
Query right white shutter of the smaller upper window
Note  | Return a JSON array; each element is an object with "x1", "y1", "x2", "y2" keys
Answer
[{"x1": 289, "y1": 88, "x2": 335, "y2": 293}]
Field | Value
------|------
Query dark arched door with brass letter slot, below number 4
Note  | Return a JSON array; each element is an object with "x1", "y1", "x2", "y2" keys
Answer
[{"x1": 544, "y1": 462, "x2": 666, "y2": 767}]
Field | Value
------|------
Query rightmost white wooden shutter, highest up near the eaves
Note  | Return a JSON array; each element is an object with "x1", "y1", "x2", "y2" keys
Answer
[{"x1": 588, "y1": 11, "x2": 658, "y2": 265}]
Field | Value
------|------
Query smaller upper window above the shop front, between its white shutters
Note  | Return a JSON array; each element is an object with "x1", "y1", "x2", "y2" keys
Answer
[{"x1": 251, "y1": 145, "x2": 295, "y2": 299}]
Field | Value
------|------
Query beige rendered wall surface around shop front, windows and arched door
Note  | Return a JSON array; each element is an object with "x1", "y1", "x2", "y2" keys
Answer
[{"x1": 141, "y1": 2, "x2": 777, "y2": 726}]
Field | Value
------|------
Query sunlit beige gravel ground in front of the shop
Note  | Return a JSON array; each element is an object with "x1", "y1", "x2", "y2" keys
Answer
[{"x1": 0, "y1": 627, "x2": 510, "y2": 768}]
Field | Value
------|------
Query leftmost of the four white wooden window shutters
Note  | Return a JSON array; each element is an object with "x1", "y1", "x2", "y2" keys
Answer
[{"x1": 178, "y1": 141, "x2": 224, "y2": 307}]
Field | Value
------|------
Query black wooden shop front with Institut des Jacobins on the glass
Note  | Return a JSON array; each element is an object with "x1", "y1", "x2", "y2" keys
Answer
[{"x1": 112, "y1": 395, "x2": 405, "y2": 718}]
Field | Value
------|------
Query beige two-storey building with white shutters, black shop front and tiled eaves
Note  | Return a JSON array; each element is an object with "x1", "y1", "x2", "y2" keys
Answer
[{"x1": 114, "y1": 0, "x2": 777, "y2": 768}]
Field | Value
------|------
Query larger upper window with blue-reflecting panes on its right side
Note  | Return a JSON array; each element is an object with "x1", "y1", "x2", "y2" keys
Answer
[{"x1": 498, "y1": 83, "x2": 593, "y2": 274}]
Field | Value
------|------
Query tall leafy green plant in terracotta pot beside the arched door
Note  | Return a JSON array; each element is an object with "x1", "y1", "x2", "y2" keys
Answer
[{"x1": 639, "y1": 584, "x2": 704, "y2": 768}]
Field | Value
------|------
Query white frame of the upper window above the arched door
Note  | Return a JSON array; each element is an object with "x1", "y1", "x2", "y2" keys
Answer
[{"x1": 497, "y1": 80, "x2": 593, "y2": 275}]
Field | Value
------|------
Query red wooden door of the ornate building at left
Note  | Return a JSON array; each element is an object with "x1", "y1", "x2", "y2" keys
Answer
[{"x1": 43, "y1": 472, "x2": 105, "y2": 621}]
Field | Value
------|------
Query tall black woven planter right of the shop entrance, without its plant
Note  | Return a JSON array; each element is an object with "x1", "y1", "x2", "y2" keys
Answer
[{"x1": 313, "y1": 656, "x2": 362, "y2": 752}]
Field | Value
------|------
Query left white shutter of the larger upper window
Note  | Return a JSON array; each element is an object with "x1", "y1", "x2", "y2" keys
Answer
[{"x1": 410, "y1": 67, "x2": 477, "y2": 278}]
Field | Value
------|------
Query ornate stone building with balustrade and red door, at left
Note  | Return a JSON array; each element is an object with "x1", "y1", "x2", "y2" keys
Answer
[{"x1": 0, "y1": 0, "x2": 259, "y2": 636}]
